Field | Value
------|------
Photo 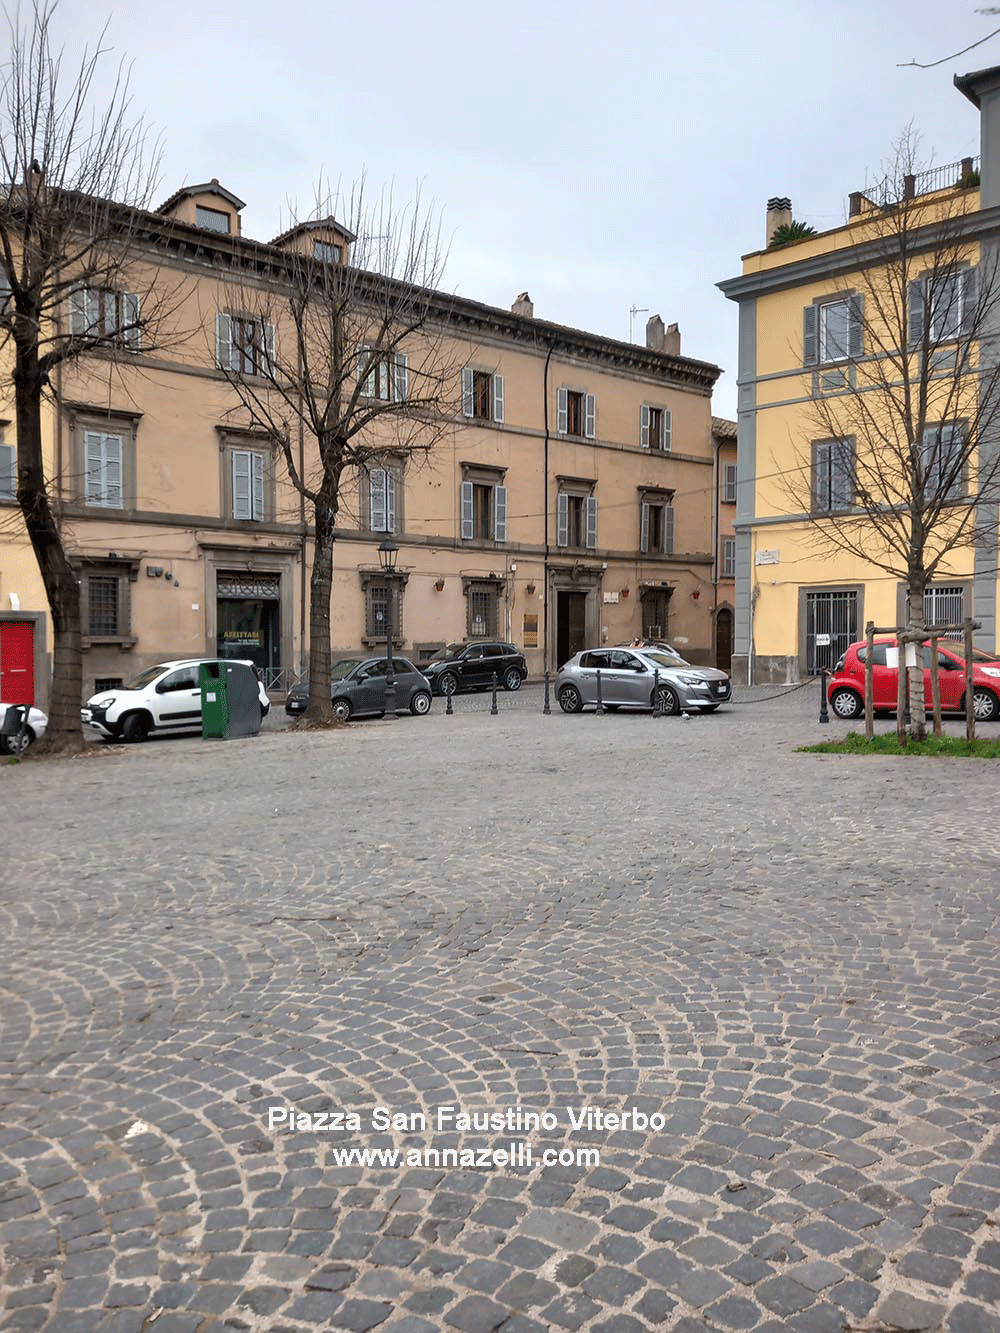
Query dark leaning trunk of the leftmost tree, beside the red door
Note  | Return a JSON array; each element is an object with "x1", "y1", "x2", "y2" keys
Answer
[{"x1": 13, "y1": 341, "x2": 84, "y2": 753}]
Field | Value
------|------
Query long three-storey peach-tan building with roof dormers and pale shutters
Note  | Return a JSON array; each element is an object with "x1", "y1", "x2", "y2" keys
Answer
[{"x1": 0, "y1": 181, "x2": 719, "y2": 705}]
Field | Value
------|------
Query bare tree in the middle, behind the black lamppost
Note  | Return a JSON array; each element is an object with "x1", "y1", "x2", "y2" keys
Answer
[{"x1": 217, "y1": 183, "x2": 457, "y2": 721}]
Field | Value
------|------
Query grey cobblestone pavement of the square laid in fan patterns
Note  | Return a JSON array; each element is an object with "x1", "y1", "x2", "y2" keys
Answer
[{"x1": 0, "y1": 686, "x2": 1000, "y2": 1333}]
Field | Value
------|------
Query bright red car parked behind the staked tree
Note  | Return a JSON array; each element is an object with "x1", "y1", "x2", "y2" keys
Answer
[{"x1": 827, "y1": 639, "x2": 1000, "y2": 722}]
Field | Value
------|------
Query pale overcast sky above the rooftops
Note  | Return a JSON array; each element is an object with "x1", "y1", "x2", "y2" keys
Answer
[{"x1": 45, "y1": 0, "x2": 1000, "y2": 419}]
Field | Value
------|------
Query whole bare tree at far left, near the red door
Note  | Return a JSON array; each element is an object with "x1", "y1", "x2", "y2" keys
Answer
[{"x1": 0, "y1": 0, "x2": 172, "y2": 749}]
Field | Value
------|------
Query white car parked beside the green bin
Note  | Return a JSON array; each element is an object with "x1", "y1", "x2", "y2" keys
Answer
[{"x1": 80, "y1": 657, "x2": 271, "y2": 742}]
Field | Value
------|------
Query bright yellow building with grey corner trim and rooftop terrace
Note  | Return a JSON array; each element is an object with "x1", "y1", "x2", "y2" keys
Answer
[{"x1": 719, "y1": 68, "x2": 1000, "y2": 682}]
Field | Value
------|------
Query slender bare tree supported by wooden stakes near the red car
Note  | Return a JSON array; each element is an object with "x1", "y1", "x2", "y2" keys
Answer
[{"x1": 785, "y1": 131, "x2": 1000, "y2": 737}]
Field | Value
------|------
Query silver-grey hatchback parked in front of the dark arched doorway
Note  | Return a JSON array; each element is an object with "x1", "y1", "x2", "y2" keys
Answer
[{"x1": 556, "y1": 648, "x2": 732, "y2": 714}]
